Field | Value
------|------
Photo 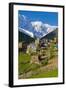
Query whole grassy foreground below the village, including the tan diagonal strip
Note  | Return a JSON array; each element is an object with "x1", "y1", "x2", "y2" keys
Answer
[{"x1": 18, "y1": 52, "x2": 58, "y2": 79}]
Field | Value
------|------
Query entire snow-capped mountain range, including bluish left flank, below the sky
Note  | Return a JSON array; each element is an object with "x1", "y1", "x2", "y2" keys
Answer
[{"x1": 18, "y1": 14, "x2": 57, "y2": 38}]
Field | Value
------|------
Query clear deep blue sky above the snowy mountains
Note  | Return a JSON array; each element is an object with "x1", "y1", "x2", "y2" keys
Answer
[{"x1": 18, "y1": 10, "x2": 58, "y2": 26}]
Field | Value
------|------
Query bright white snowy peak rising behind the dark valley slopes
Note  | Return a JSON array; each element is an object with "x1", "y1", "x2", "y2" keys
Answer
[{"x1": 31, "y1": 21, "x2": 57, "y2": 38}]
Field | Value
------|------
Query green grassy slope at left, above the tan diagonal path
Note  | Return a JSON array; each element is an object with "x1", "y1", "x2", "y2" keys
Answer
[{"x1": 18, "y1": 53, "x2": 39, "y2": 75}]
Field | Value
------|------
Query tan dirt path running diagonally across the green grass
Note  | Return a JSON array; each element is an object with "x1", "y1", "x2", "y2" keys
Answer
[{"x1": 19, "y1": 57, "x2": 58, "y2": 79}]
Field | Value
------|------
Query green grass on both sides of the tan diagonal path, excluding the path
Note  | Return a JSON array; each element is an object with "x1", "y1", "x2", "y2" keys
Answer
[{"x1": 18, "y1": 52, "x2": 58, "y2": 78}]
